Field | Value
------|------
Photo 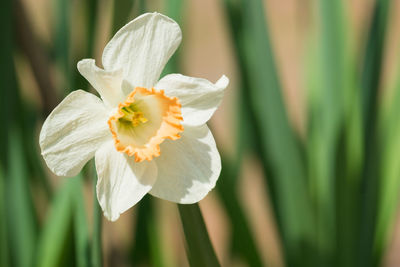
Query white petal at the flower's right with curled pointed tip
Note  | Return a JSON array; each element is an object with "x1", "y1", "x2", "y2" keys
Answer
[{"x1": 155, "y1": 74, "x2": 229, "y2": 126}]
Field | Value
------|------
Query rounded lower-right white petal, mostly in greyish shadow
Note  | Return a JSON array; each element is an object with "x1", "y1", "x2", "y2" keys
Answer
[{"x1": 149, "y1": 125, "x2": 221, "y2": 204}]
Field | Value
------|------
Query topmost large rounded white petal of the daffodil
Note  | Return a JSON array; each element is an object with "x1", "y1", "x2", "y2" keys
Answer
[{"x1": 103, "y1": 13, "x2": 182, "y2": 88}]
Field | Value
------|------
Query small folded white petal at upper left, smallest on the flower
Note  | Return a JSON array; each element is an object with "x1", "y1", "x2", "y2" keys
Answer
[{"x1": 78, "y1": 59, "x2": 124, "y2": 107}]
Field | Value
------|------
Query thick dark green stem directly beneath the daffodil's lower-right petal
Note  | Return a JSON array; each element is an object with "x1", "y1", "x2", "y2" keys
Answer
[{"x1": 178, "y1": 203, "x2": 220, "y2": 267}]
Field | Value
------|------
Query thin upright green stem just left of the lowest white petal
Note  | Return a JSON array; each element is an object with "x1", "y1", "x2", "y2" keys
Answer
[{"x1": 92, "y1": 174, "x2": 103, "y2": 267}]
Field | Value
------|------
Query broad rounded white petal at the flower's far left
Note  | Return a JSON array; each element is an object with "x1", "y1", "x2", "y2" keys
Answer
[{"x1": 39, "y1": 90, "x2": 111, "y2": 176}]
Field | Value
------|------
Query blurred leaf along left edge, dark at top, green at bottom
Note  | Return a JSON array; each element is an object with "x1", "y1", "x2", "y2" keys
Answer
[{"x1": 4, "y1": 1, "x2": 37, "y2": 267}]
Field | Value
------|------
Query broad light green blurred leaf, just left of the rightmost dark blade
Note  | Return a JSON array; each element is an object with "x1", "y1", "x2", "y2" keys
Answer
[{"x1": 307, "y1": 0, "x2": 354, "y2": 266}]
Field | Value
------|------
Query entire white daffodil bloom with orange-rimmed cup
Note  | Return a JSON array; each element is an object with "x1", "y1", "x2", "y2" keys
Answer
[{"x1": 40, "y1": 13, "x2": 229, "y2": 221}]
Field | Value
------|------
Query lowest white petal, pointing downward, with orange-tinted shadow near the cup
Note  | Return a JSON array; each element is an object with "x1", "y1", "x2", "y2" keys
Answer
[{"x1": 95, "y1": 142, "x2": 157, "y2": 221}]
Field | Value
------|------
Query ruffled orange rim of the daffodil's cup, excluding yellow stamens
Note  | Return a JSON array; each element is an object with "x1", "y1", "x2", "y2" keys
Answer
[{"x1": 108, "y1": 87, "x2": 184, "y2": 162}]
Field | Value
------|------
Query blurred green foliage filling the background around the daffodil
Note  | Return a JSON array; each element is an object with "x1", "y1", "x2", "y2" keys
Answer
[{"x1": 0, "y1": 0, "x2": 400, "y2": 267}]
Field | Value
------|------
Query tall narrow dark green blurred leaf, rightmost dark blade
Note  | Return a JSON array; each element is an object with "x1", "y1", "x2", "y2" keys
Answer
[{"x1": 359, "y1": 0, "x2": 391, "y2": 266}]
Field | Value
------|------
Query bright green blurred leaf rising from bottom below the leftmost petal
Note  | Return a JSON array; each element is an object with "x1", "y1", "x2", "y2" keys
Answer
[{"x1": 37, "y1": 177, "x2": 79, "y2": 267}]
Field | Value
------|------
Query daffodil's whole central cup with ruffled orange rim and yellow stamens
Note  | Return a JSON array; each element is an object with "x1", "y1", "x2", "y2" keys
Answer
[{"x1": 108, "y1": 87, "x2": 183, "y2": 162}]
